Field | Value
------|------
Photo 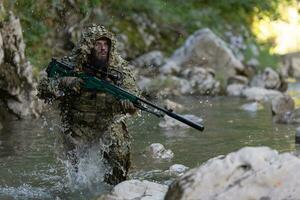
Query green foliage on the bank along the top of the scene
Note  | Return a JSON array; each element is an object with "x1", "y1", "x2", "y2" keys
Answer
[{"x1": 4, "y1": 0, "x2": 290, "y2": 72}]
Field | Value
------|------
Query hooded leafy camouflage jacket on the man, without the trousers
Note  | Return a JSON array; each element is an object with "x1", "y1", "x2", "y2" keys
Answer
[{"x1": 38, "y1": 25, "x2": 138, "y2": 128}]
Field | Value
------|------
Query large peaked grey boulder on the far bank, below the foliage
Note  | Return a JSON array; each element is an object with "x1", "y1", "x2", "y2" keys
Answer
[{"x1": 161, "y1": 28, "x2": 245, "y2": 86}]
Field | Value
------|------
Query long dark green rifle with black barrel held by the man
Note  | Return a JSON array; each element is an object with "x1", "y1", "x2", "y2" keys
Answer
[{"x1": 47, "y1": 58, "x2": 204, "y2": 131}]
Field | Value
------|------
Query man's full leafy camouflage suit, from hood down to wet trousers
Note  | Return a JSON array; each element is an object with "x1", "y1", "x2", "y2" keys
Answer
[{"x1": 38, "y1": 25, "x2": 137, "y2": 184}]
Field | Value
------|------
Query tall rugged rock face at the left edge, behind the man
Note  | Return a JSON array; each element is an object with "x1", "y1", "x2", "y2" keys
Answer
[{"x1": 0, "y1": 10, "x2": 41, "y2": 118}]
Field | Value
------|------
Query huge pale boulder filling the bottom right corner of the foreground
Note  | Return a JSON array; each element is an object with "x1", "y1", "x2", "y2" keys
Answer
[{"x1": 165, "y1": 147, "x2": 300, "y2": 200}]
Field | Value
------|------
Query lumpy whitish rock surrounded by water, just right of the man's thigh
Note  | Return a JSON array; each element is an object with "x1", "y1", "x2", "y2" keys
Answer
[{"x1": 149, "y1": 143, "x2": 174, "y2": 160}]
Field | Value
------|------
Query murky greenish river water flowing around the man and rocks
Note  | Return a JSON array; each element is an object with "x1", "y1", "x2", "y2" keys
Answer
[{"x1": 0, "y1": 85, "x2": 299, "y2": 199}]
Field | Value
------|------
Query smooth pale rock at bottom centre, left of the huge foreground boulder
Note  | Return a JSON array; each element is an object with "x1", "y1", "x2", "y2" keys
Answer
[{"x1": 97, "y1": 180, "x2": 168, "y2": 200}]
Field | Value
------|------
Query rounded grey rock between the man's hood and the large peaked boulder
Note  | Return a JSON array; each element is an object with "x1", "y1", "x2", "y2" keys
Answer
[{"x1": 132, "y1": 51, "x2": 165, "y2": 68}]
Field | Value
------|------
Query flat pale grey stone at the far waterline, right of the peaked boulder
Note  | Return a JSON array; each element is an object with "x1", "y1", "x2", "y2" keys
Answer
[{"x1": 242, "y1": 87, "x2": 283, "y2": 101}]
